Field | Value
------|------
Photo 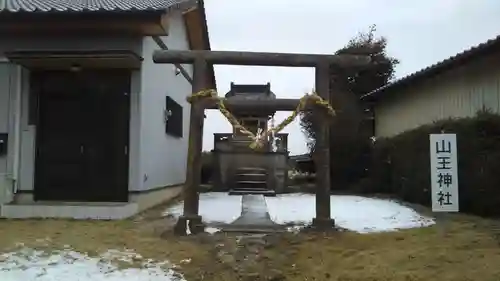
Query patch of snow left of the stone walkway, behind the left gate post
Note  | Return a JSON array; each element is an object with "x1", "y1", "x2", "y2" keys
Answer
[{"x1": 164, "y1": 192, "x2": 242, "y2": 223}]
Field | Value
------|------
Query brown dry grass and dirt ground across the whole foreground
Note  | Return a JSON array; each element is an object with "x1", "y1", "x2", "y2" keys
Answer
[{"x1": 0, "y1": 200, "x2": 500, "y2": 281}]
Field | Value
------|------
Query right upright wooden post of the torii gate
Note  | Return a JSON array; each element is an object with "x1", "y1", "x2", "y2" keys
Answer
[{"x1": 312, "y1": 62, "x2": 335, "y2": 230}]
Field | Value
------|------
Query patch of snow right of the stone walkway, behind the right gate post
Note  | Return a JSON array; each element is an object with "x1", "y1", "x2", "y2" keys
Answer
[{"x1": 266, "y1": 194, "x2": 435, "y2": 233}]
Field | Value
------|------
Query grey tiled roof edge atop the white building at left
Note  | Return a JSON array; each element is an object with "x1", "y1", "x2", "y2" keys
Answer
[{"x1": 0, "y1": 0, "x2": 196, "y2": 13}]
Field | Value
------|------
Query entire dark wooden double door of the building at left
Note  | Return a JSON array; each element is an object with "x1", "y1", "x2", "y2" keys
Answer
[{"x1": 32, "y1": 71, "x2": 130, "y2": 202}]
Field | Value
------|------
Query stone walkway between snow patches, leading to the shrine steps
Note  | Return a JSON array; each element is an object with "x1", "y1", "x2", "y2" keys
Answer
[{"x1": 222, "y1": 194, "x2": 285, "y2": 233}]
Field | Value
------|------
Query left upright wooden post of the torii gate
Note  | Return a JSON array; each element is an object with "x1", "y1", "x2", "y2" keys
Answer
[{"x1": 174, "y1": 58, "x2": 207, "y2": 235}]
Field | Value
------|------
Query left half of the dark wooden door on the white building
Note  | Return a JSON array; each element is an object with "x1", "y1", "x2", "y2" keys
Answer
[{"x1": 31, "y1": 72, "x2": 85, "y2": 201}]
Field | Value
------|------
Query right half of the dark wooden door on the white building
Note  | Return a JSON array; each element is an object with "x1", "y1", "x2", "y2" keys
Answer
[{"x1": 80, "y1": 71, "x2": 130, "y2": 202}]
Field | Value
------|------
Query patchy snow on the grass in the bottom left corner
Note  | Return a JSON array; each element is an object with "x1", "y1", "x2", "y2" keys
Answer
[{"x1": 0, "y1": 248, "x2": 185, "y2": 281}]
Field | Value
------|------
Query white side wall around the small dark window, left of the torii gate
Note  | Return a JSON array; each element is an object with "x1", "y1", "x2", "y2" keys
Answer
[{"x1": 137, "y1": 12, "x2": 192, "y2": 190}]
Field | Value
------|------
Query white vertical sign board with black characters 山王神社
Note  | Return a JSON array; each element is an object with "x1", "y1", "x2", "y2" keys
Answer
[{"x1": 429, "y1": 134, "x2": 459, "y2": 212}]
